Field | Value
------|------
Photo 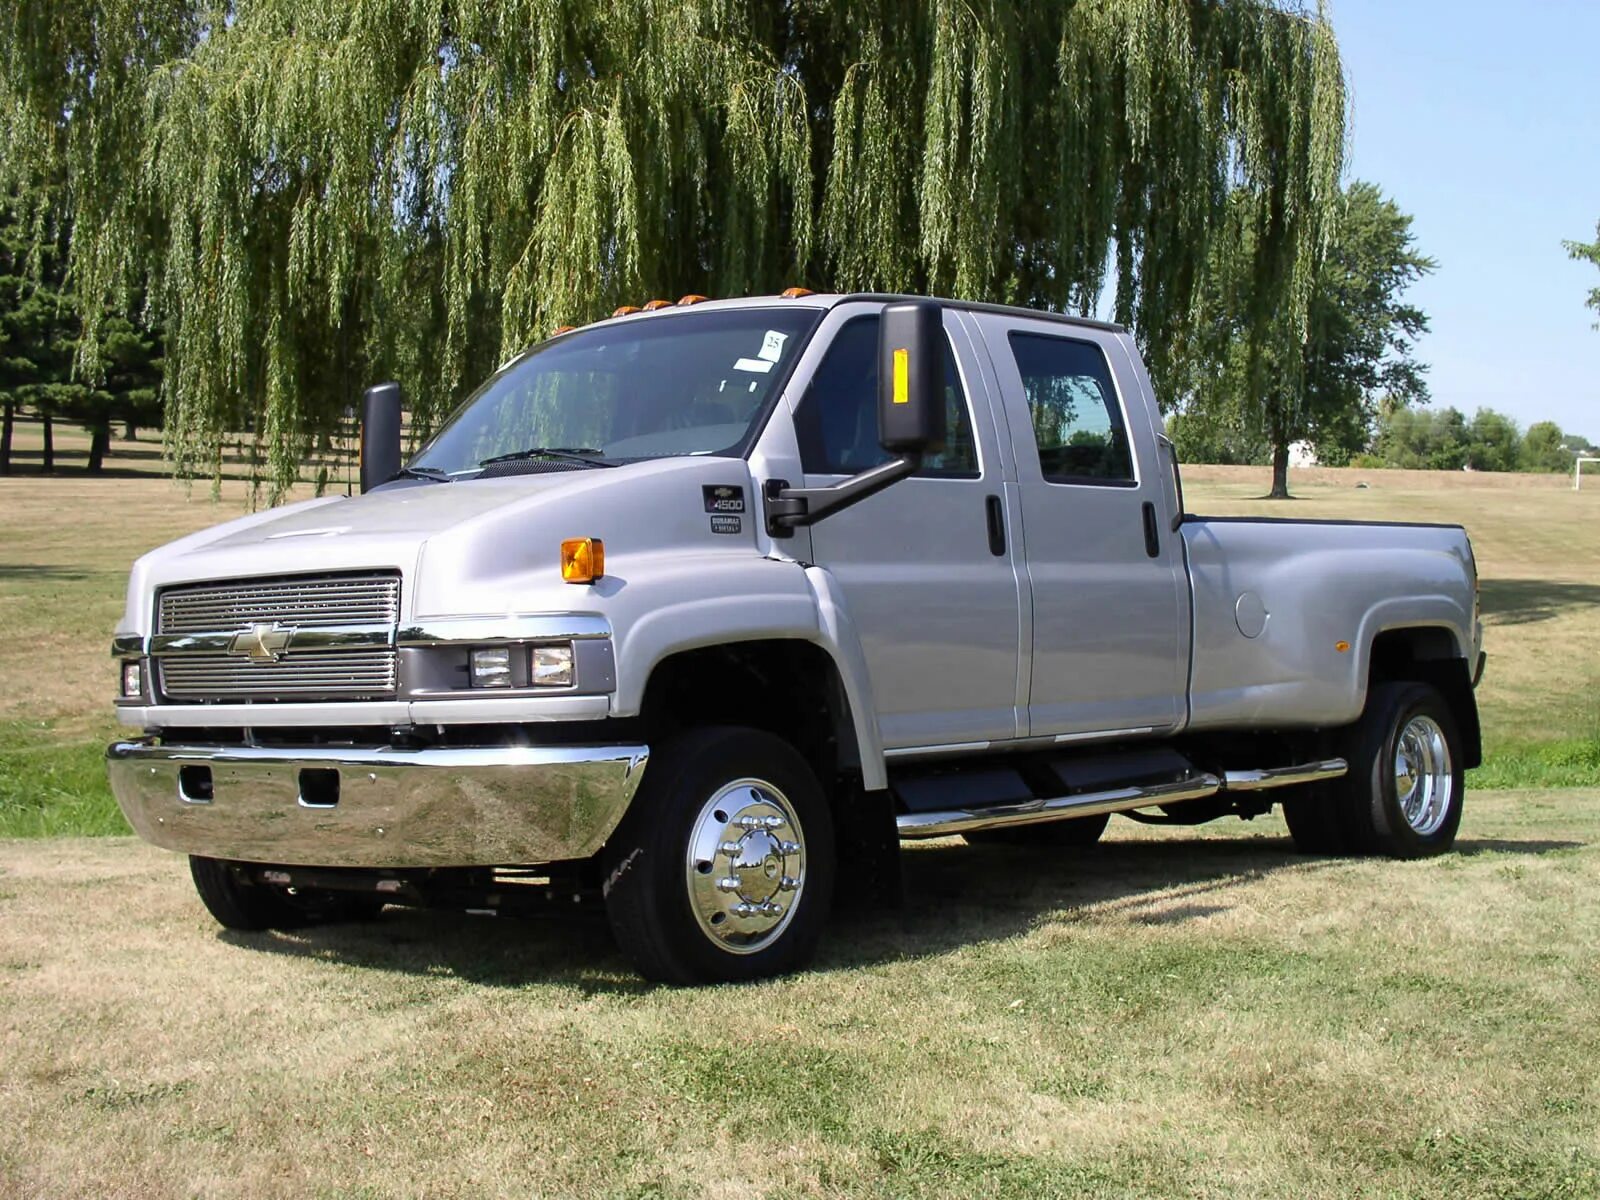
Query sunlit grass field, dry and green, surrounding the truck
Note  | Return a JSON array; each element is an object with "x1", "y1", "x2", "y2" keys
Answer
[{"x1": 0, "y1": 454, "x2": 1600, "y2": 1200}]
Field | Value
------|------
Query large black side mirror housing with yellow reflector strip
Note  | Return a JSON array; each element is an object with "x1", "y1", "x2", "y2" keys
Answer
[{"x1": 878, "y1": 301, "x2": 944, "y2": 458}]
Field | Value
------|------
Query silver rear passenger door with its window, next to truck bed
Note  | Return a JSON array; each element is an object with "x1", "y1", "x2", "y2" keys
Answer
[{"x1": 970, "y1": 312, "x2": 1189, "y2": 741}]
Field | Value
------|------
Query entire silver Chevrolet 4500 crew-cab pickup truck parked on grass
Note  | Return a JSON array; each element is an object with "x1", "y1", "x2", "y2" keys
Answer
[{"x1": 107, "y1": 291, "x2": 1483, "y2": 982}]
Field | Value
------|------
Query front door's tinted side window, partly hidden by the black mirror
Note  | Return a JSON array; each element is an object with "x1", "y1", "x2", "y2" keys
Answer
[{"x1": 795, "y1": 317, "x2": 978, "y2": 478}]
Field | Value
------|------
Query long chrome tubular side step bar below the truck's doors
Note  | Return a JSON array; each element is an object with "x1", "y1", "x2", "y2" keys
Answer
[{"x1": 894, "y1": 758, "x2": 1349, "y2": 838}]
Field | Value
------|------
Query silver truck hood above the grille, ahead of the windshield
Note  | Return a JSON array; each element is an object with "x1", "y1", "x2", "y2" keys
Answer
[{"x1": 118, "y1": 456, "x2": 755, "y2": 634}]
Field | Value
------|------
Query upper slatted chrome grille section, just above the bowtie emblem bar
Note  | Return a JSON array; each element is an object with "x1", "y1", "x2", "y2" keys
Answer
[{"x1": 157, "y1": 574, "x2": 400, "y2": 634}]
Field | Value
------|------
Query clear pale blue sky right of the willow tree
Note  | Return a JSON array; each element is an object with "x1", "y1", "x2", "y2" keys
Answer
[{"x1": 1331, "y1": 0, "x2": 1600, "y2": 442}]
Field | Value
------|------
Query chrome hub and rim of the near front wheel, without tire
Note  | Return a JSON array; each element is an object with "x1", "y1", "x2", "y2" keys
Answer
[{"x1": 685, "y1": 779, "x2": 805, "y2": 954}]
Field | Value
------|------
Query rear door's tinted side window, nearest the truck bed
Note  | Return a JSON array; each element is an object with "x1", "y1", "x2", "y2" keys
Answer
[{"x1": 1010, "y1": 333, "x2": 1134, "y2": 486}]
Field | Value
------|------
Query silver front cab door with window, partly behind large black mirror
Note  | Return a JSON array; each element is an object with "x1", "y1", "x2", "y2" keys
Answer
[{"x1": 795, "y1": 304, "x2": 1022, "y2": 750}]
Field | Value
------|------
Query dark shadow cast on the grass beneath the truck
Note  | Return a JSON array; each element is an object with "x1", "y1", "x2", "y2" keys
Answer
[{"x1": 218, "y1": 837, "x2": 1586, "y2": 995}]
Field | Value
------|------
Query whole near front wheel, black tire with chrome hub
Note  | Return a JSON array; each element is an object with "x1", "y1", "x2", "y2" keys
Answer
[{"x1": 603, "y1": 728, "x2": 834, "y2": 984}]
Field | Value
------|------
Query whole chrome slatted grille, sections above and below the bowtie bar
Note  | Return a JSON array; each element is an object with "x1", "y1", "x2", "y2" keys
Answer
[{"x1": 157, "y1": 574, "x2": 400, "y2": 702}]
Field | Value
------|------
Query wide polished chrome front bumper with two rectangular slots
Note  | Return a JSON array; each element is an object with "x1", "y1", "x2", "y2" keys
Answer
[{"x1": 106, "y1": 741, "x2": 650, "y2": 867}]
